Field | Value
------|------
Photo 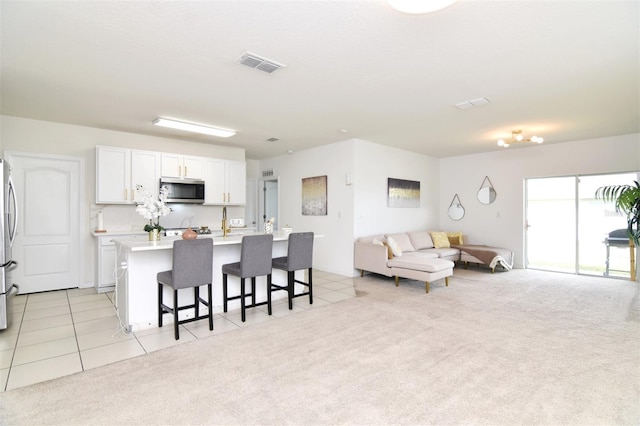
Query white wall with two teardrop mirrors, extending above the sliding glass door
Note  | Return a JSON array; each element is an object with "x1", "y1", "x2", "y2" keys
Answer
[{"x1": 439, "y1": 134, "x2": 640, "y2": 268}]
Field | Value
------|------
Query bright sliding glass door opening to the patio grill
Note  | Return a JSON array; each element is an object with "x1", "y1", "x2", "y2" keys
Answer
[{"x1": 525, "y1": 173, "x2": 638, "y2": 278}]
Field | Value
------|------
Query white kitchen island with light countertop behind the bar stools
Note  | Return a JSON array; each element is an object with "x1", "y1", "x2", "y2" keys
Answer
[{"x1": 114, "y1": 232, "x2": 304, "y2": 331}]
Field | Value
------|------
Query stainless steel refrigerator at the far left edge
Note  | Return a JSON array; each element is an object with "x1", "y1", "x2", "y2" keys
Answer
[{"x1": 0, "y1": 159, "x2": 19, "y2": 330}]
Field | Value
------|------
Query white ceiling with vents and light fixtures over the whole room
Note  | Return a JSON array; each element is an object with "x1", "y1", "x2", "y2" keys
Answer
[{"x1": 0, "y1": 0, "x2": 640, "y2": 159}]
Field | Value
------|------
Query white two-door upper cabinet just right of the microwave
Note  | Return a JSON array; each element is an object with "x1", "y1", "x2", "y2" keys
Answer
[{"x1": 204, "y1": 158, "x2": 247, "y2": 205}]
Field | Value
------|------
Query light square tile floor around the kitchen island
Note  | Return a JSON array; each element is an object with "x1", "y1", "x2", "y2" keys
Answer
[{"x1": 0, "y1": 269, "x2": 355, "y2": 392}]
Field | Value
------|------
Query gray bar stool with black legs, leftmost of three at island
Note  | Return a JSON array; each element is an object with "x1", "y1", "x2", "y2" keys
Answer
[{"x1": 158, "y1": 238, "x2": 213, "y2": 340}]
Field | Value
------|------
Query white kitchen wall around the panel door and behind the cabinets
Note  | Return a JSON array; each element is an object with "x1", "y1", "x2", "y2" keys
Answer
[{"x1": 0, "y1": 116, "x2": 245, "y2": 286}]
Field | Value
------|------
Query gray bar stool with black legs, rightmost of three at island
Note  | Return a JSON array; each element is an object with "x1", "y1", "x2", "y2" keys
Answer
[{"x1": 271, "y1": 232, "x2": 313, "y2": 309}]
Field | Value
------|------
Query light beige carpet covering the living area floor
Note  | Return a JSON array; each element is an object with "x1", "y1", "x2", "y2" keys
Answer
[{"x1": 0, "y1": 269, "x2": 640, "y2": 425}]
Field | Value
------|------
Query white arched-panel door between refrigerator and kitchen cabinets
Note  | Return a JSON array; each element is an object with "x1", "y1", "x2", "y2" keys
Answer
[{"x1": 8, "y1": 154, "x2": 82, "y2": 294}]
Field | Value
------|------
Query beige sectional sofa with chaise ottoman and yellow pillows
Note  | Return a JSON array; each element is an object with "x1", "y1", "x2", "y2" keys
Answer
[{"x1": 354, "y1": 231, "x2": 462, "y2": 292}]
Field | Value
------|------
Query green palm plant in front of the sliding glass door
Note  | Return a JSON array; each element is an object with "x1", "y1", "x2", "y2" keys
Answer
[{"x1": 595, "y1": 181, "x2": 640, "y2": 281}]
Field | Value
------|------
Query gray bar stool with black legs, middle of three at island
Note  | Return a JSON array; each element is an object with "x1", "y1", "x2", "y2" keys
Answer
[{"x1": 222, "y1": 234, "x2": 273, "y2": 322}]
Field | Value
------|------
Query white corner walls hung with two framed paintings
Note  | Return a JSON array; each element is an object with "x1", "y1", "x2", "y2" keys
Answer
[{"x1": 258, "y1": 139, "x2": 439, "y2": 276}]
